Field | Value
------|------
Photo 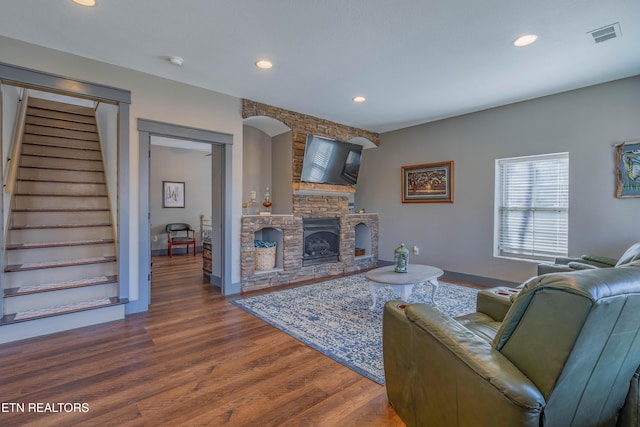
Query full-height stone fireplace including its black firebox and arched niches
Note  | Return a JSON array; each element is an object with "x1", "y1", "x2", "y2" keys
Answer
[{"x1": 240, "y1": 99, "x2": 379, "y2": 291}]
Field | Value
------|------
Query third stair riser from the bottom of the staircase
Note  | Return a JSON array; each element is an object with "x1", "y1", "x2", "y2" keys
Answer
[{"x1": 4, "y1": 262, "x2": 118, "y2": 289}]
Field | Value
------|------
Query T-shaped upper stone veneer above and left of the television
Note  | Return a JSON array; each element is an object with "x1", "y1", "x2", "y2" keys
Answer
[{"x1": 242, "y1": 99, "x2": 380, "y2": 182}]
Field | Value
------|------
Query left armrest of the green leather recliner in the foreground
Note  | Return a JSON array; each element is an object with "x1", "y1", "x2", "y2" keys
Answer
[{"x1": 383, "y1": 301, "x2": 545, "y2": 426}]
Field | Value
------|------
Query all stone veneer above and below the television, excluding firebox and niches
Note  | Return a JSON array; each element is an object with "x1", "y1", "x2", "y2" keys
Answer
[{"x1": 240, "y1": 99, "x2": 380, "y2": 291}]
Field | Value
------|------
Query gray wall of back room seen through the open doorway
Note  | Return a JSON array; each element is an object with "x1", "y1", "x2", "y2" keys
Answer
[{"x1": 149, "y1": 144, "x2": 211, "y2": 254}]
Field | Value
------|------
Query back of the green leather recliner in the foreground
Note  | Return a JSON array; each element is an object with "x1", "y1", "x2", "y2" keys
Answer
[{"x1": 493, "y1": 267, "x2": 640, "y2": 426}]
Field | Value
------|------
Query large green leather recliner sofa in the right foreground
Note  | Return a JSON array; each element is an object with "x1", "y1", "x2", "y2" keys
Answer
[{"x1": 383, "y1": 267, "x2": 640, "y2": 427}]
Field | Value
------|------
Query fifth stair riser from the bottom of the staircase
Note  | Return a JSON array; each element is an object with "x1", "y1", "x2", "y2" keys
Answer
[{"x1": 7, "y1": 227, "x2": 113, "y2": 244}]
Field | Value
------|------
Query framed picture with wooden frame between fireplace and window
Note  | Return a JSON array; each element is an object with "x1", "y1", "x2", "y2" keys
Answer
[{"x1": 402, "y1": 161, "x2": 453, "y2": 203}]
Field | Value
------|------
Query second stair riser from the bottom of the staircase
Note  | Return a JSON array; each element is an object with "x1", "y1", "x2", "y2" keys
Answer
[{"x1": 4, "y1": 283, "x2": 118, "y2": 313}]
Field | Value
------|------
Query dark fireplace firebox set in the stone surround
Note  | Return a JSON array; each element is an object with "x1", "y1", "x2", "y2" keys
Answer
[{"x1": 302, "y1": 218, "x2": 340, "y2": 267}]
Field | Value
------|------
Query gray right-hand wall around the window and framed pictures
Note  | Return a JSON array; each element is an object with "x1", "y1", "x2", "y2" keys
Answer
[{"x1": 356, "y1": 76, "x2": 640, "y2": 282}]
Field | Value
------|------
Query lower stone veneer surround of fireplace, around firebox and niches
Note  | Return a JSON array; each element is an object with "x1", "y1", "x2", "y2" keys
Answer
[{"x1": 240, "y1": 195, "x2": 378, "y2": 291}]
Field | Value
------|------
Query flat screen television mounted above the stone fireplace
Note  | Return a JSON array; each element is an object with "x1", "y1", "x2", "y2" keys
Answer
[{"x1": 300, "y1": 135, "x2": 362, "y2": 186}]
